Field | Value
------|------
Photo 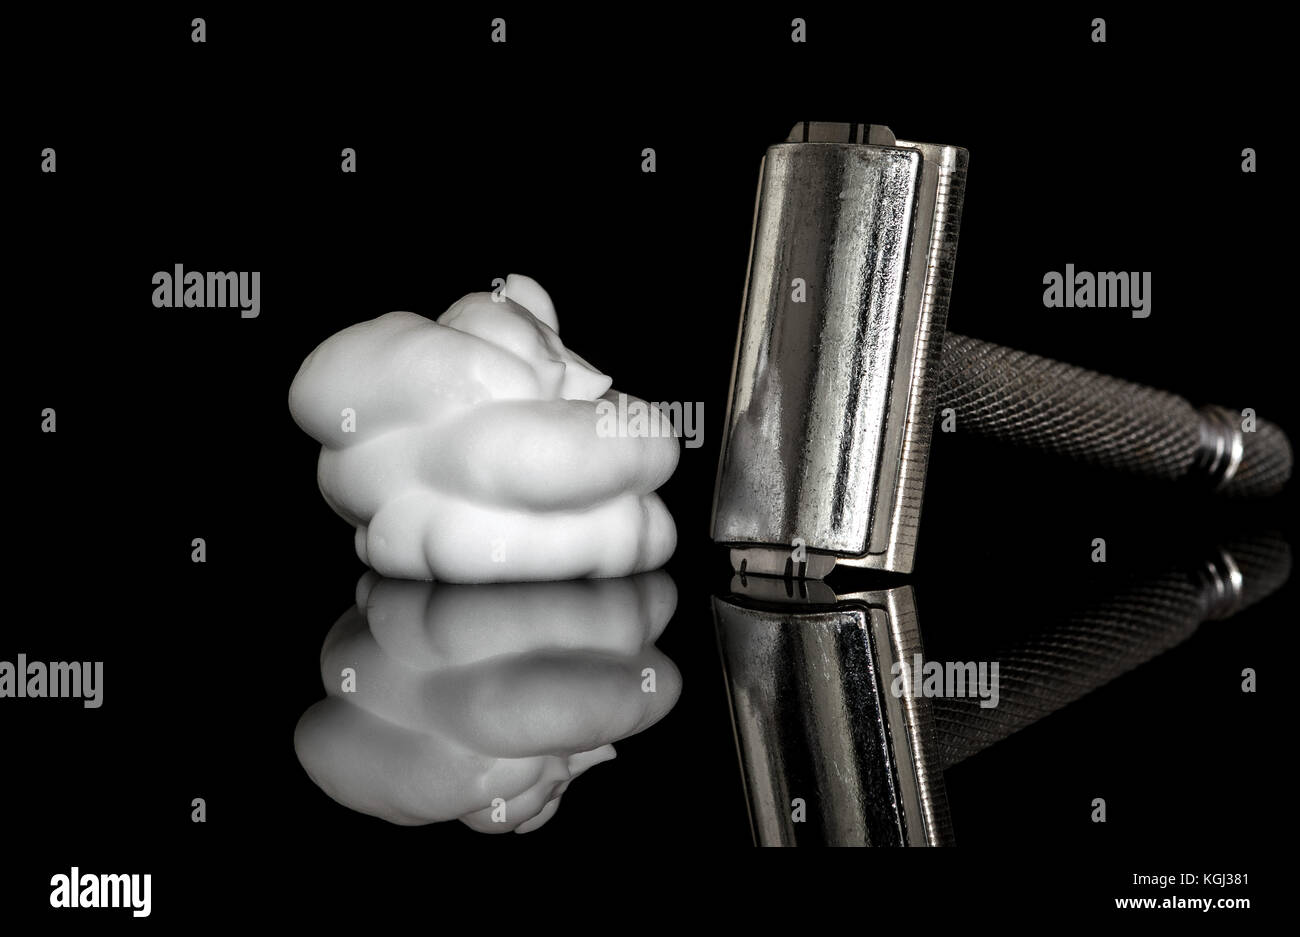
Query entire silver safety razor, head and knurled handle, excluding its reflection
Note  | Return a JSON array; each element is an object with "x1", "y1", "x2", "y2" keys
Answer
[{"x1": 712, "y1": 122, "x2": 1291, "y2": 578}]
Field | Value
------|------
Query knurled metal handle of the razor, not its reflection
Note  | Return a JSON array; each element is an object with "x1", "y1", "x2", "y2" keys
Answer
[{"x1": 939, "y1": 333, "x2": 1291, "y2": 496}]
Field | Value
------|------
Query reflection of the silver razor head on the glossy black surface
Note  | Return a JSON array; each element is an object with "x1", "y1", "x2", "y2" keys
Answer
[{"x1": 714, "y1": 576, "x2": 952, "y2": 846}]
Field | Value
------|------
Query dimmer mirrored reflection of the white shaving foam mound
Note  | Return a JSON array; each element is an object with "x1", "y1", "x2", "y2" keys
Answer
[{"x1": 294, "y1": 572, "x2": 681, "y2": 833}]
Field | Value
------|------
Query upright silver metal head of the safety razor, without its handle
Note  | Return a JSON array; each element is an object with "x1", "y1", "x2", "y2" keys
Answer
[{"x1": 712, "y1": 123, "x2": 967, "y2": 578}]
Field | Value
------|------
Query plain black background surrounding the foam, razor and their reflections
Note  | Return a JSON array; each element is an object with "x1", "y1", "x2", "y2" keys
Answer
[{"x1": 0, "y1": 8, "x2": 1296, "y2": 920}]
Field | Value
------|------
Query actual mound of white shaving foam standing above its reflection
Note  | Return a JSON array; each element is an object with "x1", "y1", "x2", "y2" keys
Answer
[{"x1": 289, "y1": 274, "x2": 679, "y2": 582}]
